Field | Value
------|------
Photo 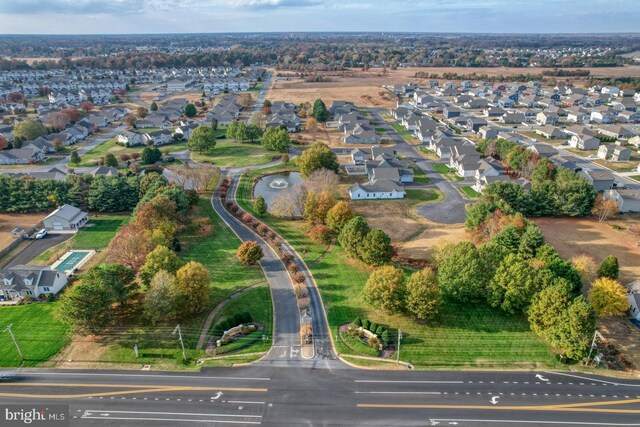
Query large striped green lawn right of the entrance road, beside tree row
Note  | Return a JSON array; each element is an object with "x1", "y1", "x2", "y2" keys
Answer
[{"x1": 238, "y1": 174, "x2": 557, "y2": 369}]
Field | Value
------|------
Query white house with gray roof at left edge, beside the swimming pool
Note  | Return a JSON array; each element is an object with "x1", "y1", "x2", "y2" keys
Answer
[{"x1": 0, "y1": 265, "x2": 67, "y2": 300}]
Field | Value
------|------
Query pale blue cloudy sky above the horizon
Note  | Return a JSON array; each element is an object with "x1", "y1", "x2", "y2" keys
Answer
[{"x1": 0, "y1": 0, "x2": 640, "y2": 34}]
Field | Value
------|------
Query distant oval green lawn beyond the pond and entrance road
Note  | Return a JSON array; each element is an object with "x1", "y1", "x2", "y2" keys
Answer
[{"x1": 191, "y1": 140, "x2": 278, "y2": 167}]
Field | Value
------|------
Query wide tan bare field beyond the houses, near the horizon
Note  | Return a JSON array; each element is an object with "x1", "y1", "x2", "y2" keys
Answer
[{"x1": 267, "y1": 65, "x2": 640, "y2": 107}]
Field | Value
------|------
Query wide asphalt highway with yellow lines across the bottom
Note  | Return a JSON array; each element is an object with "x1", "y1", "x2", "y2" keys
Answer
[{"x1": 0, "y1": 364, "x2": 640, "y2": 426}]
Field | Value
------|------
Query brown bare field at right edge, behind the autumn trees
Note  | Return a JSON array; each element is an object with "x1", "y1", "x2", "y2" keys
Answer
[{"x1": 534, "y1": 217, "x2": 640, "y2": 284}]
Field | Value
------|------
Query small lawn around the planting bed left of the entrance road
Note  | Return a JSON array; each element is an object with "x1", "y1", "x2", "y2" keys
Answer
[{"x1": 209, "y1": 286, "x2": 273, "y2": 357}]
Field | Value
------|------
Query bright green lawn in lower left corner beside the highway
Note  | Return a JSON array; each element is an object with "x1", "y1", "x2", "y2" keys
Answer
[{"x1": 0, "y1": 303, "x2": 69, "y2": 367}]
